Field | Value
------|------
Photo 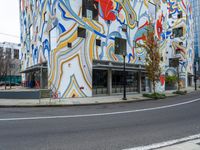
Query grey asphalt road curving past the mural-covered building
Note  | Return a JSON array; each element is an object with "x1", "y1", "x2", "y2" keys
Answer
[{"x1": 0, "y1": 92, "x2": 200, "y2": 150}]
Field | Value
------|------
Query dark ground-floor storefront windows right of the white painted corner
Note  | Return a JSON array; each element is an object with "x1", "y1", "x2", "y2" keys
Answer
[{"x1": 93, "y1": 69, "x2": 147, "y2": 95}]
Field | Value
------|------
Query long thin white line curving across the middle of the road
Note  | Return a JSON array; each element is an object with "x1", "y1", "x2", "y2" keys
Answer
[{"x1": 0, "y1": 98, "x2": 200, "y2": 121}]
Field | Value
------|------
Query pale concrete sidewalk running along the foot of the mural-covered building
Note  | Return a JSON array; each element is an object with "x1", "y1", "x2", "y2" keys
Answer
[{"x1": 0, "y1": 88, "x2": 197, "y2": 107}]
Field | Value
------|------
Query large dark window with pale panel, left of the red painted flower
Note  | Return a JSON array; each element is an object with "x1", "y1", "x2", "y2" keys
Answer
[{"x1": 82, "y1": 0, "x2": 98, "y2": 20}]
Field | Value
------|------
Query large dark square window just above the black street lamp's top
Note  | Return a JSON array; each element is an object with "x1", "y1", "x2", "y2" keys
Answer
[{"x1": 115, "y1": 37, "x2": 126, "y2": 55}]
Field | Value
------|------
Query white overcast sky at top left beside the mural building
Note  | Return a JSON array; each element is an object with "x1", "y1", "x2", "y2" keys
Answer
[{"x1": 0, "y1": 0, "x2": 20, "y2": 43}]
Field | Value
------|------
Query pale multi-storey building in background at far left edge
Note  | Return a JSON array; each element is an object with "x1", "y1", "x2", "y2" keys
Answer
[{"x1": 0, "y1": 42, "x2": 22, "y2": 85}]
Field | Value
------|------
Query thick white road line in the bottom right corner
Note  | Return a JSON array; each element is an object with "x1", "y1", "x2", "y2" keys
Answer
[{"x1": 124, "y1": 134, "x2": 200, "y2": 150}]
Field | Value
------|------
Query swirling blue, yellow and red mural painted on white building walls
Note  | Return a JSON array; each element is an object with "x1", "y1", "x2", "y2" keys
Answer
[{"x1": 20, "y1": 0, "x2": 194, "y2": 98}]
